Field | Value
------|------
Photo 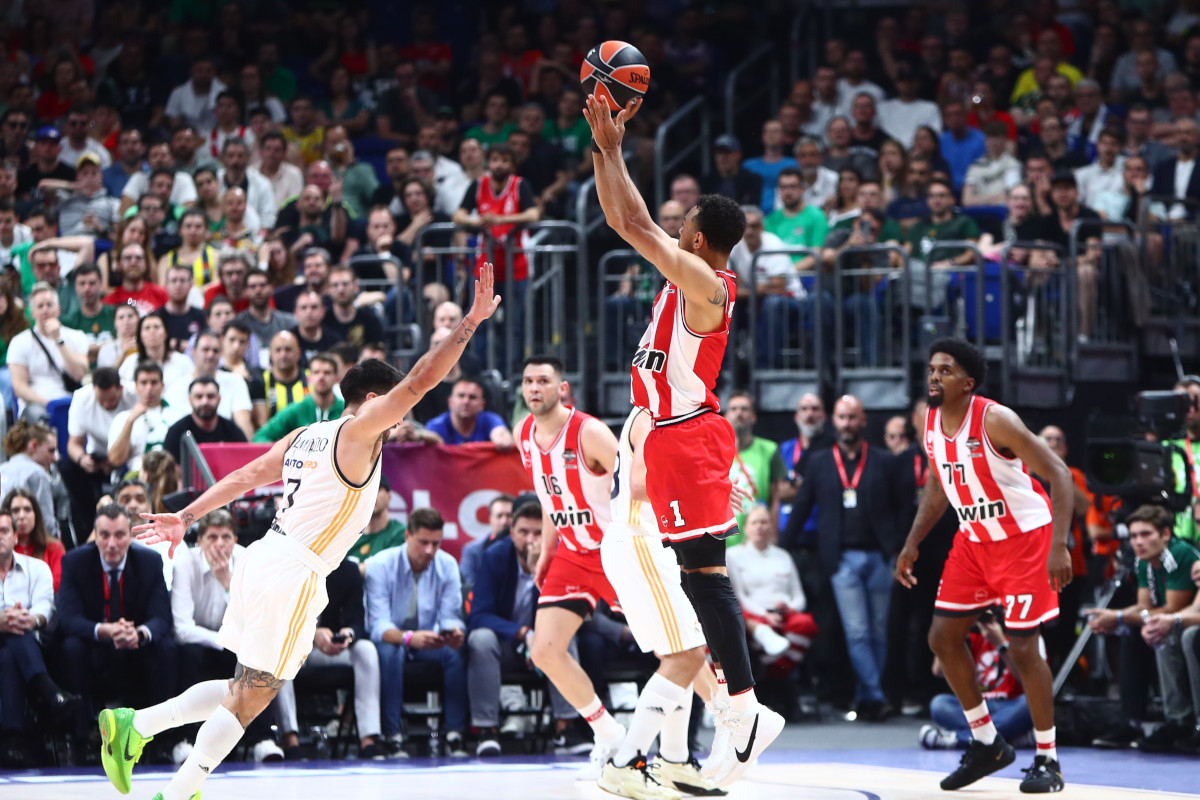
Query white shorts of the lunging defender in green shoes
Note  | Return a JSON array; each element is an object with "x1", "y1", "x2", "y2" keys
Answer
[{"x1": 217, "y1": 533, "x2": 330, "y2": 680}]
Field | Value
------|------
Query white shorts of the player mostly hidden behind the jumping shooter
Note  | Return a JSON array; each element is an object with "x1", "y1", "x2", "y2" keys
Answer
[{"x1": 600, "y1": 522, "x2": 704, "y2": 655}]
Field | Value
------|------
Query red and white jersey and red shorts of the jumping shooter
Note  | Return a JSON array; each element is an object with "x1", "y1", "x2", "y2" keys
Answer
[{"x1": 630, "y1": 271, "x2": 738, "y2": 542}]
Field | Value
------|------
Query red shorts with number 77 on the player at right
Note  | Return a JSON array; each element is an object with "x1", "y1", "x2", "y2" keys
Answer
[{"x1": 934, "y1": 525, "x2": 1058, "y2": 633}]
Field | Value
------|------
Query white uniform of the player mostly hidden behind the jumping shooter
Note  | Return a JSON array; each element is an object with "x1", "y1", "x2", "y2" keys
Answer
[{"x1": 600, "y1": 408, "x2": 704, "y2": 655}]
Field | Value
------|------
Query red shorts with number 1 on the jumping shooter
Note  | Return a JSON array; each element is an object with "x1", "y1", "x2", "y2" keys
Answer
[{"x1": 644, "y1": 413, "x2": 738, "y2": 542}]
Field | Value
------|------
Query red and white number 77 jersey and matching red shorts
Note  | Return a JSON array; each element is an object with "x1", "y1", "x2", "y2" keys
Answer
[{"x1": 925, "y1": 396, "x2": 1058, "y2": 633}]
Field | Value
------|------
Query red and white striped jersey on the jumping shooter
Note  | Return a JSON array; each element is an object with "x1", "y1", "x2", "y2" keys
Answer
[{"x1": 630, "y1": 271, "x2": 738, "y2": 420}]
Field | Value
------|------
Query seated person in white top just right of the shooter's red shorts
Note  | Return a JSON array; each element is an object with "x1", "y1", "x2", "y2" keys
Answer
[{"x1": 725, "y1": 504, "x2": 817, "y2": 678}]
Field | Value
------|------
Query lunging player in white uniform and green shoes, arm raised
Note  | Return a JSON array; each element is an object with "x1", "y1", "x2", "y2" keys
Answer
[{"x1": 100, "y1": 264, "x2": 500, "y2": 800}]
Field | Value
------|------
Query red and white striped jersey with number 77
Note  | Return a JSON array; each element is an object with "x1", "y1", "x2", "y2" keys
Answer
[{"x1": 925, "y1": 395, "x2": 1051, "y2": 542}]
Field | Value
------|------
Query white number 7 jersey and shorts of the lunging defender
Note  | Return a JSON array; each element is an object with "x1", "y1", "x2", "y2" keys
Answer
[{"x1": 217, "y1": 416, "x2": 380, "y2": 680}]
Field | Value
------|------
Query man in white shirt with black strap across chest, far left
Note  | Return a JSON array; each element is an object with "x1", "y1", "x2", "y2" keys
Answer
[{"x1": 6, "y1": 283, "x2": 88, "y2": 419}]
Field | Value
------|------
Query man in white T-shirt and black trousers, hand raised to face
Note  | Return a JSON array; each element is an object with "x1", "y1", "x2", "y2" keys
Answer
[{"x1": 59, "y1": 367, "x2": 137, "y2": 540}]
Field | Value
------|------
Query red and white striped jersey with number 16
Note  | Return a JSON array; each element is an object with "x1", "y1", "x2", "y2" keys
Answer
[{"x1": 518, "y1": 409, "x2": 612, "y2": 553}]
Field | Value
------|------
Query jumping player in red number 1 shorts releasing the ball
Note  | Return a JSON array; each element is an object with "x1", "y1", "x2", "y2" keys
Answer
[{"x1": 583, "y1": 95, "x2": 784, "y2": 786}]
